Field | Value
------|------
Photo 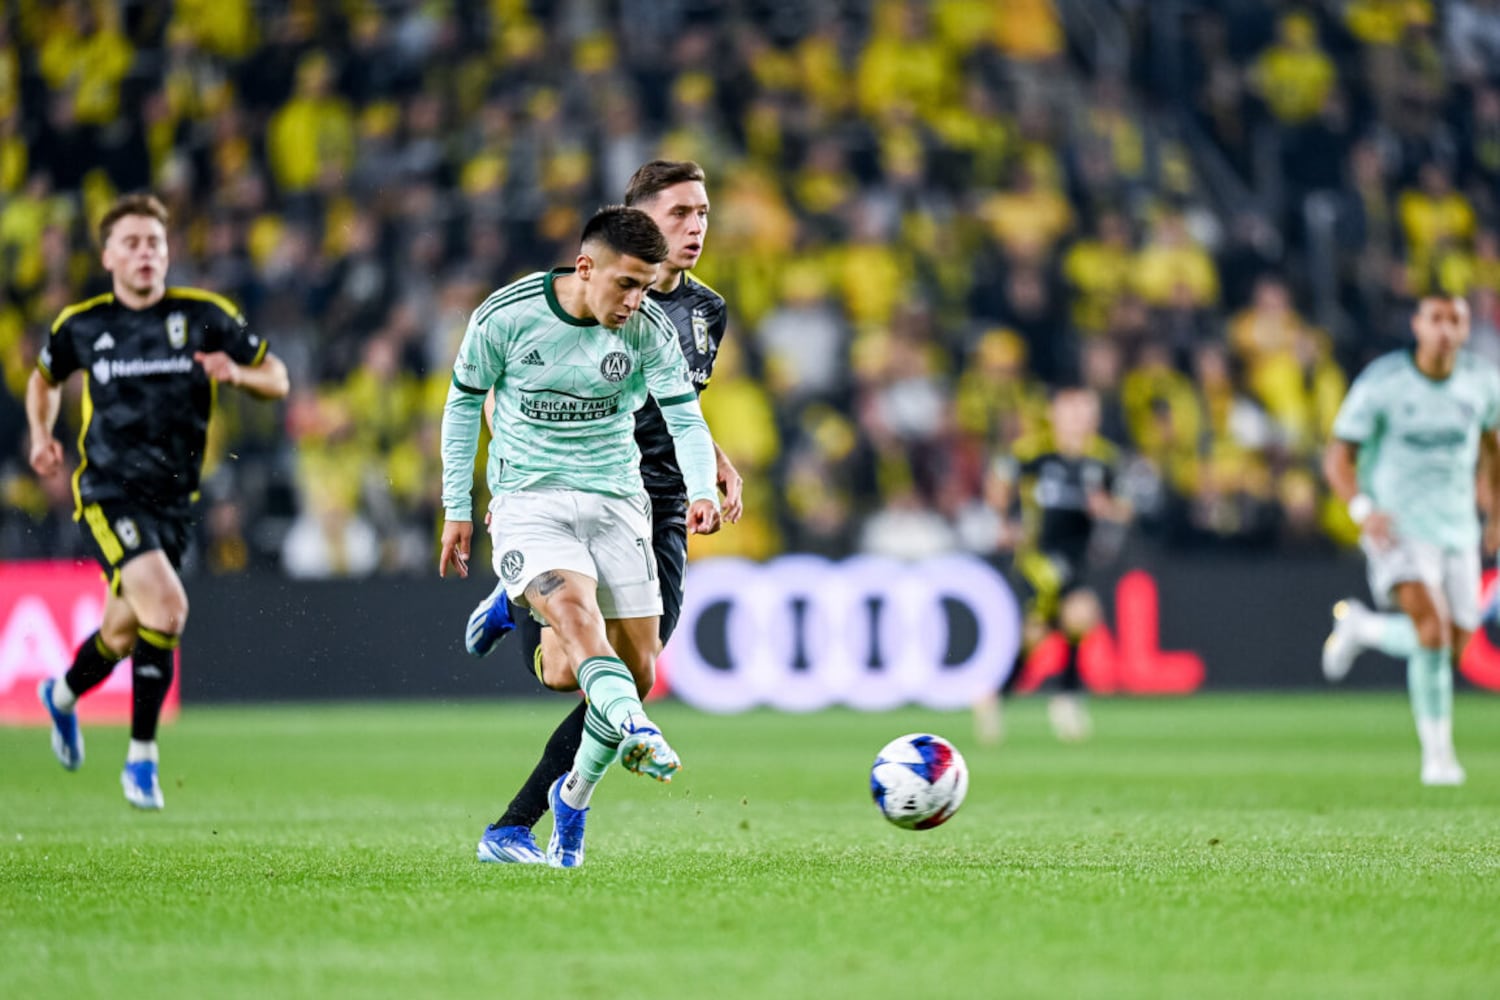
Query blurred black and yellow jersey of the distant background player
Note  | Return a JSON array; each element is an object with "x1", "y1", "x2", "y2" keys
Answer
[{"x1": 999, "y1": 435, "x2": 1119, "y2": 568}]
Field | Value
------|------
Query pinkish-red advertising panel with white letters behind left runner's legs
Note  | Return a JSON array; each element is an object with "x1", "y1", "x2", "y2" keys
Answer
[{"x1": 0, "y1": 562, "x2": 182, "y2": 726}]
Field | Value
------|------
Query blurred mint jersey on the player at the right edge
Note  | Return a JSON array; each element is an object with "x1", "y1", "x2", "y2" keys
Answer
[{"x1": 1334, "y1": 351, "x2": 1500, "y2": 549}]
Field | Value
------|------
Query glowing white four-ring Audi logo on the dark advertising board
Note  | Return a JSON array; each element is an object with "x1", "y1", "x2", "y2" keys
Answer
[{"x1": 668, "y1": 555, "x2": 1022, "y2": 712}]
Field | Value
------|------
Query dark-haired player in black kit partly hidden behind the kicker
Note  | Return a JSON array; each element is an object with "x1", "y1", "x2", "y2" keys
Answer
[{"x1": 465, "y1": 160, "x2": 741, "y2": 864}]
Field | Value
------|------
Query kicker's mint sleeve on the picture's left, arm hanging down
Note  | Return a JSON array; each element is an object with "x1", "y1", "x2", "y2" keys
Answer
[{"x1": 441, "y1": 312, "x2": 506, "y2": 520}]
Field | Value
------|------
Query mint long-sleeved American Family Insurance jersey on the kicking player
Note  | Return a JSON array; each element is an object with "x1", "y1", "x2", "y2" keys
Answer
[{"x1": 443, "y1": 268, "x2": 717, "y2": 520}]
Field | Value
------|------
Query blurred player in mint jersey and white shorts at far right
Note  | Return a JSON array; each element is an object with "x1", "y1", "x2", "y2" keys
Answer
[{"x1": 1323, "y1": 295, "x2": 1500, "y2": 786}]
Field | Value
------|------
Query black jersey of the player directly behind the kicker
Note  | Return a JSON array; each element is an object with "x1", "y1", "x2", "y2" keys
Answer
[{"x1": 636, "y1": 273, "x2": 728, "y2": 501}]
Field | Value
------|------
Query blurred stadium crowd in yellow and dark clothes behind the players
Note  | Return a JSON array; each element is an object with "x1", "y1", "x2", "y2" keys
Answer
[{"x1": 0, "y1": 0, "x2": 1500, "y2": 577}]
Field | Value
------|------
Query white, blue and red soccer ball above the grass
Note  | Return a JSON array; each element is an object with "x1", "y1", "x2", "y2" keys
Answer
[{"x1": 870, "y1": 733, "x2": 969, "y2": 831}]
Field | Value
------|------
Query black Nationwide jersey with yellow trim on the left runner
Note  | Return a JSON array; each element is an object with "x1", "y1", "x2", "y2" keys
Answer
[{"x1": 36, "y1": 288, "x2": 267, "y2": 511}]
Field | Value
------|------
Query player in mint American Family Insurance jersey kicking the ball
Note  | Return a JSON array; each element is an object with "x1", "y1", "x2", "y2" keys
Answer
[{"x1": 438, "y1": 207, "x2": 720, "y2": 868}]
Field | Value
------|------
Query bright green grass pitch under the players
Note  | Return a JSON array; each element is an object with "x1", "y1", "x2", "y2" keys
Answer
[{"x1": 0, "y1": 693, "x2": 1500, "y2": 1000}]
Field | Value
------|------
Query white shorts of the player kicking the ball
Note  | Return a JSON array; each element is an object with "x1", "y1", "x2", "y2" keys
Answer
[{"x1": 489, "y1": 490, "x2": 662, "y2": 621}]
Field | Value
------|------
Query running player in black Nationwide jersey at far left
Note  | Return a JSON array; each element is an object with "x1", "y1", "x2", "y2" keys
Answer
[{"x1": 26, "y1": 195, "x2": 288, "y2": 810}]
